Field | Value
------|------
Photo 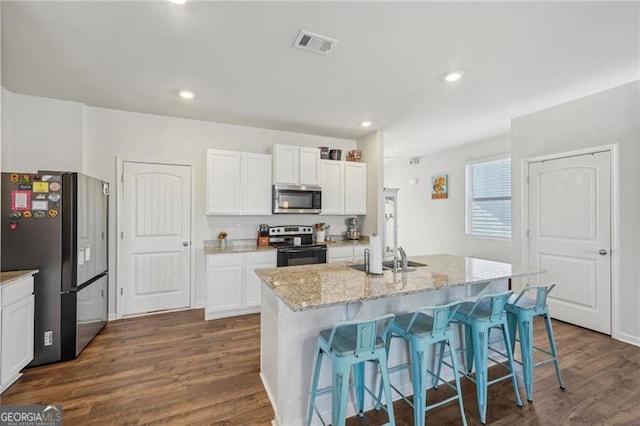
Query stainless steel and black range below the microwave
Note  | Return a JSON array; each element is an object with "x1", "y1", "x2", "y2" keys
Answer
[{"x1": 269, "y1": 225, "x2": 327, "y2": 267}]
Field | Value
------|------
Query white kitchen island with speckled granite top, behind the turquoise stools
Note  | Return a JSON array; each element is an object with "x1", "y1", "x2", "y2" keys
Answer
[{"x1": 256, "y1": 254, "x2": 542, "y2": 426}]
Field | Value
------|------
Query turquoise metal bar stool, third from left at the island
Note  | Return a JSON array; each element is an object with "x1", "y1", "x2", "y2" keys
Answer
[{"x1": 444, "y1": 291, "x2": 522, "y2": 424}]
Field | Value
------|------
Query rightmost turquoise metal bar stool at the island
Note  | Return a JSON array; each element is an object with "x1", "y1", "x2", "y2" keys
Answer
[{"x1": 504, "y1": 283, "x2": 564, "y2": 401}]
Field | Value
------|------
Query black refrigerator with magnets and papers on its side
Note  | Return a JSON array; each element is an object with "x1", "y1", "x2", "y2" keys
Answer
[{"x1": 1, "y1": 171, "x2": 109, "y2": 367}]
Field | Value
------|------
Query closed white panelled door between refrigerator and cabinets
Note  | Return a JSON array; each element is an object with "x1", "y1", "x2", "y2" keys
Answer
[{"x1": 120, "y1": 162, "x2": 191, "y2": 315}]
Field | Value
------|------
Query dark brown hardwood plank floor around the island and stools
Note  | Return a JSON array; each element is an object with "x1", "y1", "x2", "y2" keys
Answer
[{"x1": 0, "y1": 310, "x2": 640, "y2": 426}]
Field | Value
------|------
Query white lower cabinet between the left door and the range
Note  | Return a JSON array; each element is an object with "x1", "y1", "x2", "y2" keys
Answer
[{"x1": 205, "y1": 250, "x2": 276, "y2": 320}]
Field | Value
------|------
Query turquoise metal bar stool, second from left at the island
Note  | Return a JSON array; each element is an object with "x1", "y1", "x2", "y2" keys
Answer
[{"x1": 376, "y1": 302, "x2": 467, "y2": 426}]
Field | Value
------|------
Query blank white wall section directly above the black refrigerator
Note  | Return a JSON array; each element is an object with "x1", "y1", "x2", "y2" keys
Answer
[{"x1": 2, "y1": 90, "x2": 83, "y2": 173}]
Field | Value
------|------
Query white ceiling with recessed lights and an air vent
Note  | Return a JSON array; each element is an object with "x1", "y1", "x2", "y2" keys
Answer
[{"x1": 2, "y1": 1, "x2": 640, "y2": 158}]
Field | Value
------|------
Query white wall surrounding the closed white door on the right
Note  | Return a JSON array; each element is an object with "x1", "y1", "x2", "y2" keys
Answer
[{"x1": 511, "y1": 81, "x2": 640, "y2": 344}]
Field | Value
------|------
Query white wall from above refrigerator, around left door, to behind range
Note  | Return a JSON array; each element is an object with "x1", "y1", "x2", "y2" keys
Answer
[{"x1": 2, "y1": 89, "x2": 356, "y2": 314}]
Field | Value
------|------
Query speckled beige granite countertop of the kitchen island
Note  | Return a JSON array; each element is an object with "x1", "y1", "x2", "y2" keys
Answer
[{"x1": 256, "y1": 254, "x2": 544, "y2": 311}]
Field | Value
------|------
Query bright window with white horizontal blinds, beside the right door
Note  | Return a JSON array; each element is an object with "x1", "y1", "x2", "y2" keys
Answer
[{"x1": 467, "y1": 158, "x2": 511, "y2": 239}]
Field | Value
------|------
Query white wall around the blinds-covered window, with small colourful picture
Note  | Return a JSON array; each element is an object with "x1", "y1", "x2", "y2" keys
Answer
[{"x1": 384, "y1": 135, "x2": 512, "y2": 262}]
